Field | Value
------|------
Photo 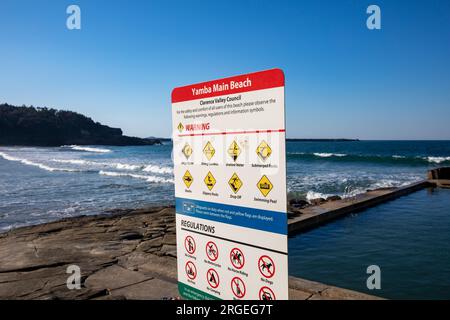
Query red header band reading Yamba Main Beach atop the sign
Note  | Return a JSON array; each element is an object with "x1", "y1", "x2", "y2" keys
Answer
[{"x1": 172, "y1": 69, "x2": 284, "y2": 103}]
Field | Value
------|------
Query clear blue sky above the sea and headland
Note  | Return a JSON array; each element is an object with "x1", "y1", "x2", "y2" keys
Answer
[{"x1": 0, "y1": 0, "x2": 450, "y2": 139}]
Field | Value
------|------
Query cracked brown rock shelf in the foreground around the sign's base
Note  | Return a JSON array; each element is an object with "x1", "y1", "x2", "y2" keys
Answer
[{"x1": 0, "y1": 207, "x2": 376, "y2": 299}]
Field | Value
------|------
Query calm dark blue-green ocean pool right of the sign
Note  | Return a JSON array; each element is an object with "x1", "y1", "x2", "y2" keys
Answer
[{"x1": 289, "y1": 188, "x2": 450, "y2": 299}]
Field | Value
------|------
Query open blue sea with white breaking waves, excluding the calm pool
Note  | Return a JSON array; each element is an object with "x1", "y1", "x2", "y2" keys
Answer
[{"x1": 0, "y1": 141, "x2": 450, "y2": 232}]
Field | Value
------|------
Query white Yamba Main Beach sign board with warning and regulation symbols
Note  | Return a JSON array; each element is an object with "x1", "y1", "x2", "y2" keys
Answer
[{"x1": 172, "y1": 69, "x2": 288, "y2": 300}]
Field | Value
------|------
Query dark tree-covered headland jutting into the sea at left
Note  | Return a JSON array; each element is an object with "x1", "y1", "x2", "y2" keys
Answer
[{"x1": 0, "y1": 104, "x2": 161, "y2": 147}]
